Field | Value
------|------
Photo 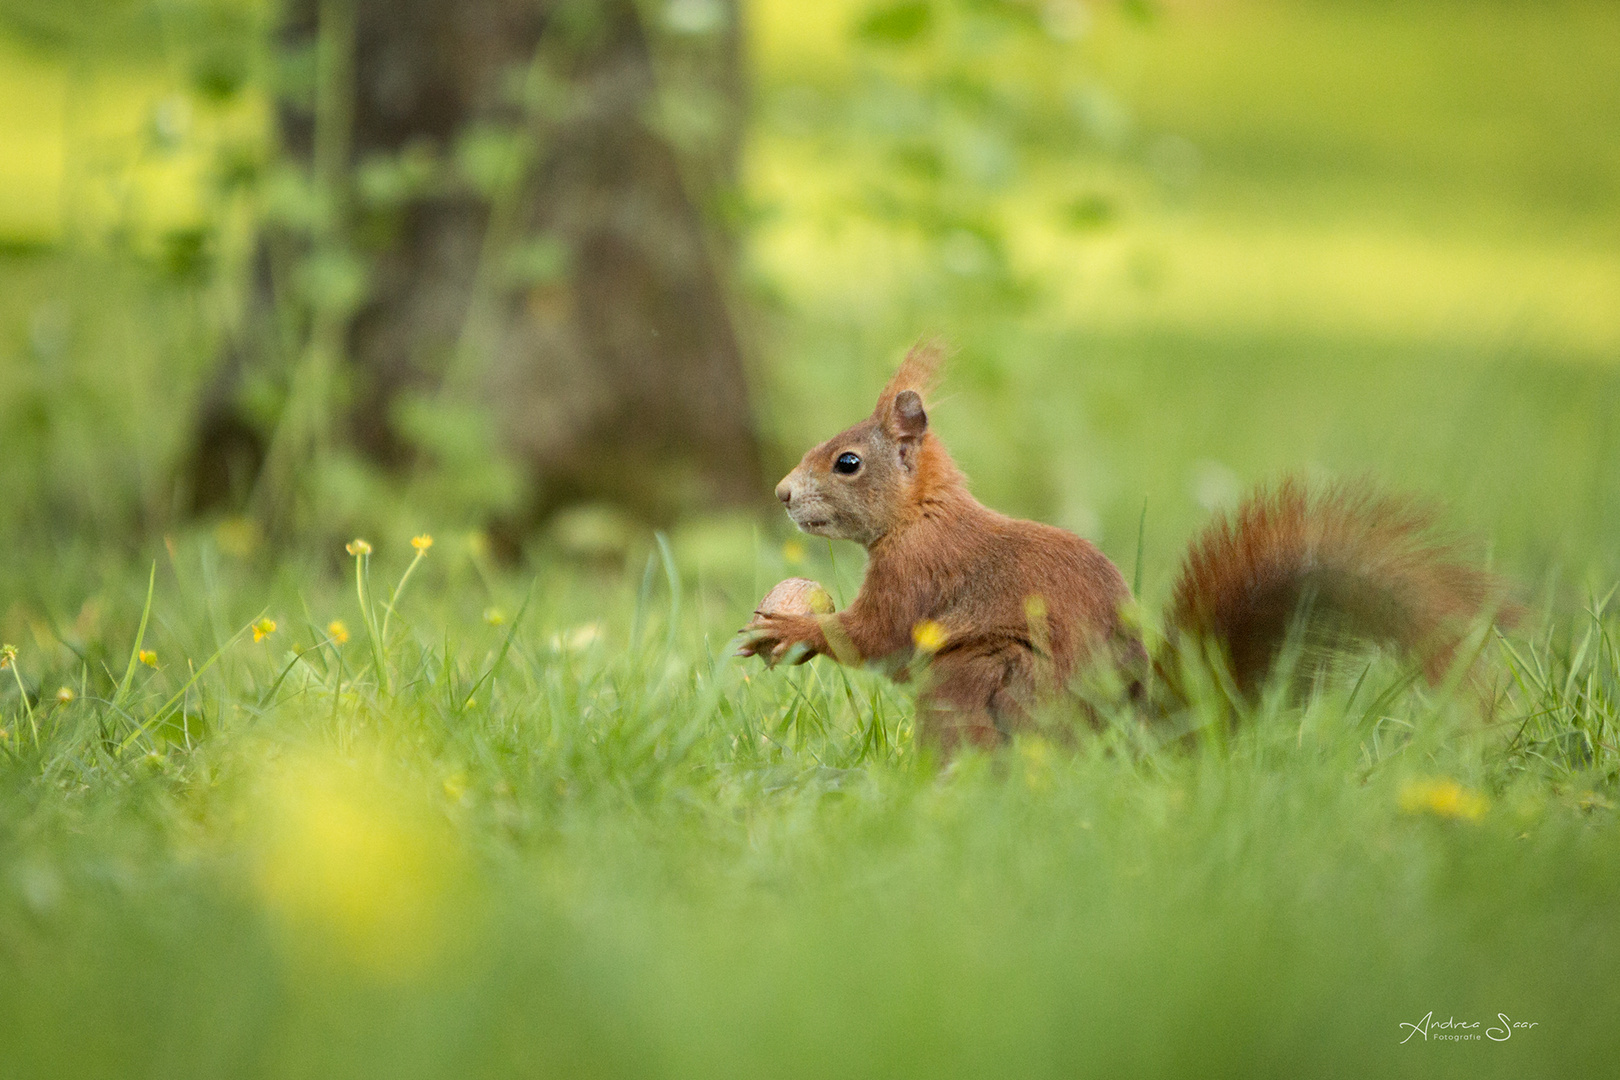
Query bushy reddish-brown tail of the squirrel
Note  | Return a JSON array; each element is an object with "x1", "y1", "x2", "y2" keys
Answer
[{"x1": 1155, "y1": 479, "x2": 1515, "y2": 698}]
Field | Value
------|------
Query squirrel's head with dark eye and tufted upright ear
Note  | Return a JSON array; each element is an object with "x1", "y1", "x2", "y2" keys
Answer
[{"x1": 776, "y1": 343, "x2": 954, "y2": 547}]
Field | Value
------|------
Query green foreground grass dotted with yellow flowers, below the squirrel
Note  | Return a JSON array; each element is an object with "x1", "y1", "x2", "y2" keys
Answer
[{"x1": 0, "y1": 536, "x2": 1620, "y2": 1077}]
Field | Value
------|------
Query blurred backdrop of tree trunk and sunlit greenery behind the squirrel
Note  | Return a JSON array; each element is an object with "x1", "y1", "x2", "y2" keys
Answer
[{"x1": 0, "y1": 0, "x2": 1620, "y2": 599}]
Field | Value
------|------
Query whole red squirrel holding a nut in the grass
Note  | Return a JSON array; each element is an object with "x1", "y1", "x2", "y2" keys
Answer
[{"x1": 739, "y1": 343, "x2": 1503, "y2": 753}]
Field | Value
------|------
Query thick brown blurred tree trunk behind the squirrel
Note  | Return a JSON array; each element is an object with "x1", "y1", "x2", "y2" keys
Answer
[{"x1": 194, "y1": 0, "x2": 760, "y2": 523}]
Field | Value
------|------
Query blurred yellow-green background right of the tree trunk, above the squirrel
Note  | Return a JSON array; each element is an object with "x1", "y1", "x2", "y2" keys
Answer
[{"x1": 750, "y1": 3, "x2": 1620, "y2": 586}]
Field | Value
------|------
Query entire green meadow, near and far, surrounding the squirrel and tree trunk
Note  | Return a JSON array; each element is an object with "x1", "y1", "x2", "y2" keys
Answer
[{"x1": 0, "y1": 0, "x2": 1620, "y2": 1078}]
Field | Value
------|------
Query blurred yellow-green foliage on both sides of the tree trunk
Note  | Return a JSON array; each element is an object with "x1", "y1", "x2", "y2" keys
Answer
[{"x1": 0, "y1": 0, "x2": 1620, "y2": 586}]
